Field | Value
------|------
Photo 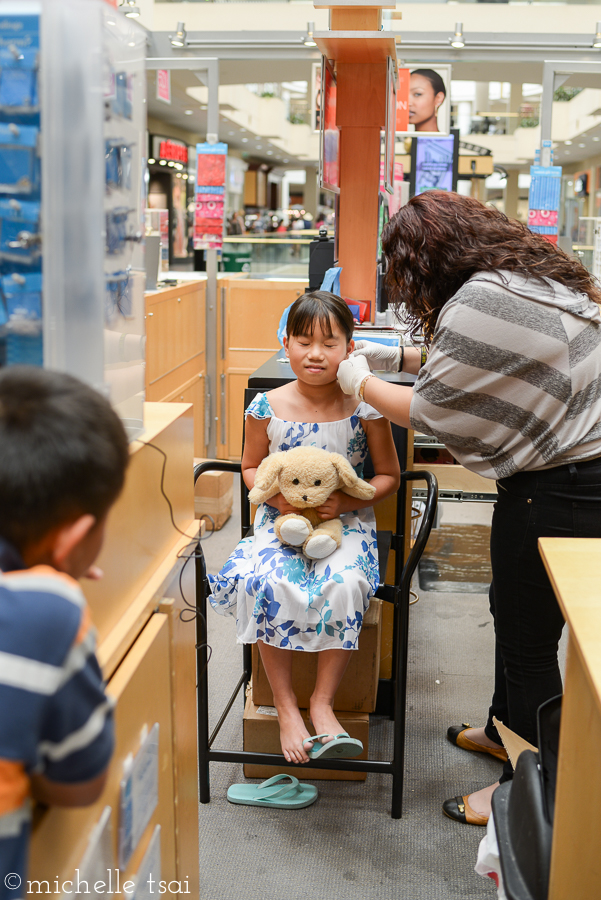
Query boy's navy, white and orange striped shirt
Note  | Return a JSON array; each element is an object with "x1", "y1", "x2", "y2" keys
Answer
[{"x1": 0, "y1": 538, "x2": 114, "y2": 900}]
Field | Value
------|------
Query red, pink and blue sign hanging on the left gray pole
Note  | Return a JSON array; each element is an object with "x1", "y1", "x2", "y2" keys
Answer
[{"x1": 194, "y1": 143, "x2": 227, "y2": 250}]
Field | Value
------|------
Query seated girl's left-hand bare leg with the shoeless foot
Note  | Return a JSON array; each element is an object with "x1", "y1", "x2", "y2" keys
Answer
[{"x1": 257, "y1": 641, "x2": 314, "y2": 763}]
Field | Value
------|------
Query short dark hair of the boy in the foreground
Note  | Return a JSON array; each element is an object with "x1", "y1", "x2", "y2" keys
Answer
[{"x1": 0, "y1": 366, "x2": 129, "y2": 552}]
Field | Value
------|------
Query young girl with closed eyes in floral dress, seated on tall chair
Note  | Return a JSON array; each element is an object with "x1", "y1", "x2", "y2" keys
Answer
[{"x1": 209, "y1": 291, "x2": 400, "y2": 763}]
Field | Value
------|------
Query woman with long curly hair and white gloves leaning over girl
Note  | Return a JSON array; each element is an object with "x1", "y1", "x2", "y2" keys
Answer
[{"x1": 338, "y1": 191, "x2": 601, "y2": 825}]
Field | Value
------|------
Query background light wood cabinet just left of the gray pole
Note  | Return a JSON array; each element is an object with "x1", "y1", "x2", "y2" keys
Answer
[{"x1": 146, "y1": 279, "x2": 206, "y2": 457}]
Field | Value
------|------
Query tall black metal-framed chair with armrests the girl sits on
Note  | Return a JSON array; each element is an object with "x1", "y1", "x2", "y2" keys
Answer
[{"x1": 194, "y1": 448, "x2": 438, "y2": 819}]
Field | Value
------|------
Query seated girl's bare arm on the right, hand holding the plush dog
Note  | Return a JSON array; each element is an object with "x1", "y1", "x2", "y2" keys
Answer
[{"x1": 317, "y1": 416, "x2": 401, "y2": 520}]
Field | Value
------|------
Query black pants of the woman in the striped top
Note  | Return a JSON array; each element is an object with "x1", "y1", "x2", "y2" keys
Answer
[{"x1": 485, "y1": 459, "x2": 601, "y2": 782}]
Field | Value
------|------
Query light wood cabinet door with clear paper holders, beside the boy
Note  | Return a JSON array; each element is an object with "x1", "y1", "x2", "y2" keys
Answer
[{"x1": 28, "y1": 615, "x2": 177, "y2": 884}]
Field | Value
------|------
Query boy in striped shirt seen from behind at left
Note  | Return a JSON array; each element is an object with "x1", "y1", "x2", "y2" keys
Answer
[{"x1": 0, "y1": 366, "x2": 129, "y2": 900}]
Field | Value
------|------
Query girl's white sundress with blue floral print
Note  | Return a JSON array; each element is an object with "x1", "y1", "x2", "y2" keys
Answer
[{"x1": 209, "y1": 394, "x2": 380, "y2": 651}]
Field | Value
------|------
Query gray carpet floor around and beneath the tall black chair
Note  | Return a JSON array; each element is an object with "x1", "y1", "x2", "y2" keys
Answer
[{"x1": 199, "y1": 493, "x2": 501, "y2": 900}]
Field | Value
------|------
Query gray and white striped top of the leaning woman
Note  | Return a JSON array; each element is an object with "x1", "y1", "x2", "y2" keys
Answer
[{"x1": 411, "y1": 272, "x2": 601, "y2": 478}]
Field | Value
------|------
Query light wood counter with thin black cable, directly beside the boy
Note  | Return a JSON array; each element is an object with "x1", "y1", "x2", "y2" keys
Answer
[{"x1": 28, "y1": 403, "x2": 199, "y2": 896}]
